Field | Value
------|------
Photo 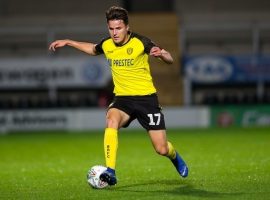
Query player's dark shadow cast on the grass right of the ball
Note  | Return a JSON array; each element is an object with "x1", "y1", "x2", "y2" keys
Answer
[{"x1": 114, "y1": 180, "x2": 243, "y2": 198}]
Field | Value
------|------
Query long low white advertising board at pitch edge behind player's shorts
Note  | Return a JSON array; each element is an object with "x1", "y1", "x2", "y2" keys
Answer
[{"x1": 0, "y1": 107, "x2": 209, "y2": 133}]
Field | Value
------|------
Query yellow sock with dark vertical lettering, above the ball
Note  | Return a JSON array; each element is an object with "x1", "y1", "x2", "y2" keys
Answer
[{"x1": 104, "y1": 128, "x2": 118, "y2": 169}]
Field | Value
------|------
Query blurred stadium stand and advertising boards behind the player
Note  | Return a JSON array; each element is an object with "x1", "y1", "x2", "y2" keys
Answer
[{"x1": 0, "y1": 0, "x2": 270, "y2": 133}]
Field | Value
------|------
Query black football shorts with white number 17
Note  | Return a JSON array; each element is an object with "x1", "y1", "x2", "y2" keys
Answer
[{"x1": 108, "y1": 94, "x2": 166, "y2": 131}]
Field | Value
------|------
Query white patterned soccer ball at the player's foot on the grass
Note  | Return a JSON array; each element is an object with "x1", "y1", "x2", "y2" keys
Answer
[{"x1": 87, "y1": 165, "x2": 108, "y2": 189}]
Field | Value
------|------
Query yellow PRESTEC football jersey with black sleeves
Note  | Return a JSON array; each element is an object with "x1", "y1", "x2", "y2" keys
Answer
[{"x1": 96, "y1": 33, "x2": 156, "y2": 96}]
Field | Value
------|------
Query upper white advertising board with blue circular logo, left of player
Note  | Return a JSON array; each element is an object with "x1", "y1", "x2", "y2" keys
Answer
[{"x1": 0, "y1": 56, "x2": 111, "y2": 88}]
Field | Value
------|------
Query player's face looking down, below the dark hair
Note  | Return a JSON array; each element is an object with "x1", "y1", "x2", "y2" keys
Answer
[{"x1": 108, "y1": 19, "x2": 129, "y2": 45}]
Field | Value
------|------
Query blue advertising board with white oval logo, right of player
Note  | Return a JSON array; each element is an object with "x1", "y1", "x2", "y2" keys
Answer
[{"x1": 183, "y1": 55, "x2": 270, "y2": 83}]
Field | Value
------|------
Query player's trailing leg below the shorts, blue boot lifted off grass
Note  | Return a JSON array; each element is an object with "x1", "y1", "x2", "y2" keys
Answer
[{"x1": 148, "y1": 130, "x2": 188, "y2": 177}]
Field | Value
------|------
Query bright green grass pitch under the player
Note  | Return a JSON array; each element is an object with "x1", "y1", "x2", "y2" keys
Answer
[{"x1": 0, "y1": 128, "x2": 270, "y2": 200}]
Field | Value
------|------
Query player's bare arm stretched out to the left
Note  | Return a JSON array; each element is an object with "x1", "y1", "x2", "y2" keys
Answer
[{"x1": 49, "y1": 39, "x2": 97, "y2": 56}]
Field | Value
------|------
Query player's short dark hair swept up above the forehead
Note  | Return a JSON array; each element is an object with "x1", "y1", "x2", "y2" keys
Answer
[{"x1": 106, "y1": 6, "x2": 128, "y2": 25}]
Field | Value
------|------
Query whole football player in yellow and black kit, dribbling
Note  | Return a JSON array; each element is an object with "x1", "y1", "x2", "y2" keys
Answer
[{"x1": 49, "y1": 6, "x2": 188, "y2": 185}]
